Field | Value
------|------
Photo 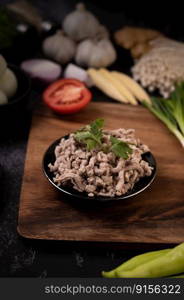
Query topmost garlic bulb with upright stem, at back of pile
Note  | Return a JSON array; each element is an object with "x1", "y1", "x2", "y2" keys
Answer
[{"x1": 62, "y1": 3, "x2": 99, "y2": 41}]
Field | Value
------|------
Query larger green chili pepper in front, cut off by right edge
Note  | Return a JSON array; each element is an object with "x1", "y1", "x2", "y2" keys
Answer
[{"x1": 115, "y1": 243, "x2": 184, "y2": 278}]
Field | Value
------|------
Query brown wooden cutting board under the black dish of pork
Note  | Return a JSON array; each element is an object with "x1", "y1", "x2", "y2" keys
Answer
[{"x1": 18, "y1": 102, "x2": 184, "y2": 243}]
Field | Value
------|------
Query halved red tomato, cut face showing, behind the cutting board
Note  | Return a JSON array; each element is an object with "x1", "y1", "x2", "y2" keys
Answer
[{"x1": 43, "y1": 79, "x2": 92, "y2": 114}]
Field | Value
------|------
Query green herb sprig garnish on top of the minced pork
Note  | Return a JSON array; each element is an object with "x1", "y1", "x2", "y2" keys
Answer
[{"x1": 75, "y1": 119, "x2": 132, "y2": 159}]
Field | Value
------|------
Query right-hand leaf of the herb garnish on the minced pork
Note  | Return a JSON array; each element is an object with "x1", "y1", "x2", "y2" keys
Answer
[{"x1": 110, "y1": 136, "x2": 133, "y2": 159}]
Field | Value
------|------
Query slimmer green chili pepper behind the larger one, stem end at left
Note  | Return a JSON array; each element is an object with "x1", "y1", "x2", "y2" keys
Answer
[{"x1": 102, "y1": 249, "x2": 171, "y2": 278}]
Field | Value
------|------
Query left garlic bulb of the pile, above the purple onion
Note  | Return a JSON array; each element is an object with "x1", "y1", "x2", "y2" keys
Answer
[{"x1": 43, "y1": 30, "x2": 76, "y2": 64}]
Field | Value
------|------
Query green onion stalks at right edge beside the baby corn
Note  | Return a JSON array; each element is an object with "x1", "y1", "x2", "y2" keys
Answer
[{"x1": 143, "y1": 83, "x2": 184, "y2": 147}]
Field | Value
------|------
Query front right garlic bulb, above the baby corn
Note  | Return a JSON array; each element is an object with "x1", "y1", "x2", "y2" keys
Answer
[{"x1": 75, "y1": 38, "x2": 116, "y2": 68}]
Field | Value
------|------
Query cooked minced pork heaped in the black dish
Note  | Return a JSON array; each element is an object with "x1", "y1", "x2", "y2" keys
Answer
[{"x1": 49, "y1": 128, "x2": 152, "y2": 197}]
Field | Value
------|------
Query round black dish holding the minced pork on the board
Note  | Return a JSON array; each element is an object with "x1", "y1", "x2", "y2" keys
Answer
[{"x1": 43, "y1": 135, "x2": 156, "y2": 202}]
